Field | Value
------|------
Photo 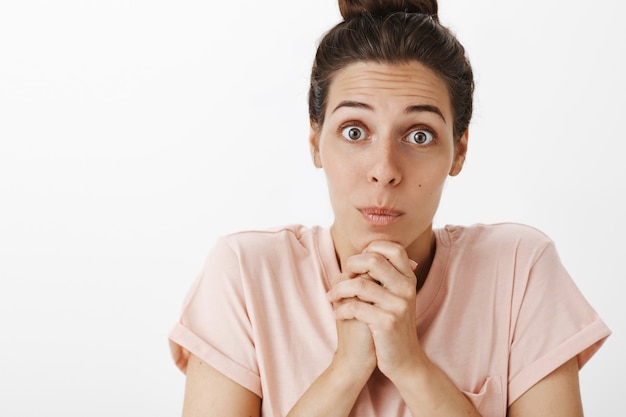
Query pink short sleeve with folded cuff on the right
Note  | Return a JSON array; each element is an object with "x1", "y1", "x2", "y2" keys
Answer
[{"x1": 508, "y1": 241, "x2": 611, "y2": 405}]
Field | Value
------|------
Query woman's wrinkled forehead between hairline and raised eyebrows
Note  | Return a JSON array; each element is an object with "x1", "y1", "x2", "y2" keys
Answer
[{"x1": 328, "y1": 62, "x2": 451, "y2": 120}]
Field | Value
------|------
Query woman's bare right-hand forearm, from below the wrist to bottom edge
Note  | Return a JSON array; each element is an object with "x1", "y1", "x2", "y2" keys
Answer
[{"x1": 394, "y1": 360, "x2": 480, "y2": 417}]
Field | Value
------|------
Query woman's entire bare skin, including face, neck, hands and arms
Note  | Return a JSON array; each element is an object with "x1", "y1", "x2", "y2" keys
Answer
[{"x1": 178, "y1": 62, "x2": 582, "y2": 417}]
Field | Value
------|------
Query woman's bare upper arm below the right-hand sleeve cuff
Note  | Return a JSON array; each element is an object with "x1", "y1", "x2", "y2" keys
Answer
[{"x1": 508, "y1": 358, "x2": 583, "y2": 417}]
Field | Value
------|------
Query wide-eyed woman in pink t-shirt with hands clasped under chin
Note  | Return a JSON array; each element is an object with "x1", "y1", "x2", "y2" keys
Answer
[{"x1": 170, "y1": 1, "x2": 610, "y2": 417}]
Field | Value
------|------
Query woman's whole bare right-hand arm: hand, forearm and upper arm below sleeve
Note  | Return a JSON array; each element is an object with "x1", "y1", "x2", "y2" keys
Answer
[{"x1": 330, "y1": 242, "x2": 583, "y2": 417}]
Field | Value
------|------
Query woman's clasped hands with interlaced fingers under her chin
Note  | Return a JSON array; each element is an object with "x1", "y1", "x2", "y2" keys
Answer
[{"x1": 328, "y1": 241, "x2": 422, "y2": 381}]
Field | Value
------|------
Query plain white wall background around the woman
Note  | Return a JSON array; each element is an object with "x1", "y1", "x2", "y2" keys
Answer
[{"x1": 0, "y1": 0, "x2": 626, "y2": 417}]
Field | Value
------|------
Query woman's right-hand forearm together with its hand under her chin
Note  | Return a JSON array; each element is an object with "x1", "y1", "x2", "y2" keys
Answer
[{"x1": 329, "y1": 241, "x2": 480, "y2": 417}]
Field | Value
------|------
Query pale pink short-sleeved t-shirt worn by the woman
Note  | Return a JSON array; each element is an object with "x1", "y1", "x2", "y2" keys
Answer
[{"x1": 170, "y1": 224, "x2": 611, "y2": 417}]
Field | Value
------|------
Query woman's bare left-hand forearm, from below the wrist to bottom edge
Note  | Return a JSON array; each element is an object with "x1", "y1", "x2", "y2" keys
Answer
[{"x1": 287, "y1": 356, "x2": 371, "y2": 417}]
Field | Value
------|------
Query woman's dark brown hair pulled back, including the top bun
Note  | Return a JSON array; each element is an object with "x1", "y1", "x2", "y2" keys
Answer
[{"x1": 309, "y1": 0, "x2": 474, "y2": 139}]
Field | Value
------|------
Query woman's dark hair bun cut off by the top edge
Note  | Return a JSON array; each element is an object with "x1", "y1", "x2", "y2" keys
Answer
[{"x1": 339, "y1": 0, "x2": 437, "y2": 20}]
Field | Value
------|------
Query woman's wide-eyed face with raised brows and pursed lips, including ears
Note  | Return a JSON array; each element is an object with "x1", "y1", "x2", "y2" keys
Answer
[{"x1": 310, "y1": 62, "x2": 467, "y2": 260}]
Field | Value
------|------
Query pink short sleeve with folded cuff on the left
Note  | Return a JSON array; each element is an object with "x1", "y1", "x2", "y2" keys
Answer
[{"x1": 169, "y1": 238, "x2": 262, "y2": 397}]
